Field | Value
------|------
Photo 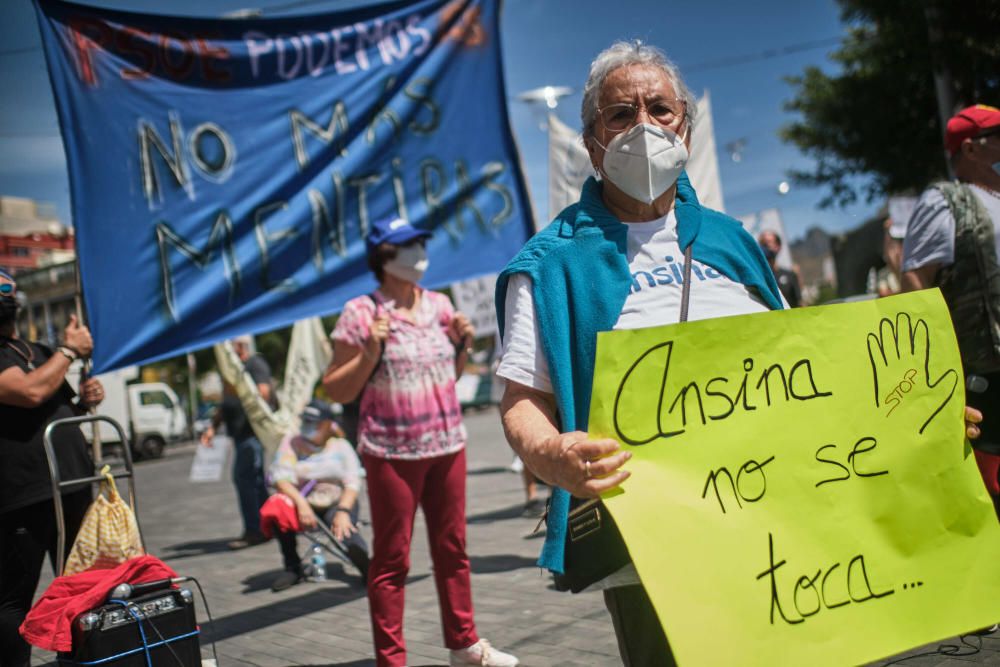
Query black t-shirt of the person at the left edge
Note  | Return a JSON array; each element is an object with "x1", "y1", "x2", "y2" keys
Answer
[{"x1": 0, "y1": 338, "x2": 94, "y2": 516}]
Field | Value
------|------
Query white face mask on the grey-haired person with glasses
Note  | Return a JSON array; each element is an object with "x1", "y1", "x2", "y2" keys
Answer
[{"x1": 598, "y1": 123, "x2": 688, "y2": 204}]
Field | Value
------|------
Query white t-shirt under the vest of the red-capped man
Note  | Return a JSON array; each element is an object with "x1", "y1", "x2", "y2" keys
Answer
[{"x1": 903, "y1": 184, "x2": 1000, "y2": 271}]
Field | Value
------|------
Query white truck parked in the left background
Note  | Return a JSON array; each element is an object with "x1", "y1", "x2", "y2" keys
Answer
[{"x1": 67, "y1": 364, "x2": 189, "y2": 458}]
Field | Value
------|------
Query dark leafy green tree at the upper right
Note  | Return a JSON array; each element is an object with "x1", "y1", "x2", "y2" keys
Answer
[{"x1": 780, "y1": 0, "x2": 1000, "y2": 206}]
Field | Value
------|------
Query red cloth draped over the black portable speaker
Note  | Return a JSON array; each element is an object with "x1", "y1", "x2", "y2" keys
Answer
[{"x1": 20, "y1": 556, "x2": 177, "y2": 651}]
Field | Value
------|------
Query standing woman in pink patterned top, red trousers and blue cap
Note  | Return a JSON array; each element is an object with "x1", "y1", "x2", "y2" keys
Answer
[{"x1": 323, "y1": 219, "x2": 517, "y2": 667}]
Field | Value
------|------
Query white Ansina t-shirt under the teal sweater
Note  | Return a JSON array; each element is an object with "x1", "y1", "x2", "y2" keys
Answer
[{"x1": 497, "y1": 211, "x2": 776, "y2": 591}]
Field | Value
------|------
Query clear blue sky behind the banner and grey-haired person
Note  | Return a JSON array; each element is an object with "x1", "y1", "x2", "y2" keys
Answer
[{"x1": 0, "y1": 0, "x2": 879, "y2": 239}]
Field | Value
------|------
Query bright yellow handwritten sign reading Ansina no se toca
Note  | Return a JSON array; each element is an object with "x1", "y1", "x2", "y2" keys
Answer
[{"x1": 590, "y1": 290, "x2": 1000, "y2": 665}]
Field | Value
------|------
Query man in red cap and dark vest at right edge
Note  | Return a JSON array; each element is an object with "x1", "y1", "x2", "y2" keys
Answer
[{"x1": 903, "y1": 104, "x2": 1000, "y2": 512}]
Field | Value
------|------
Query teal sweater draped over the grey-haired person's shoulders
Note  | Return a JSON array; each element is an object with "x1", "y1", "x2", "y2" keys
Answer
[{"x1": 496, "y1": 173, "x2": 782, "y2": 573}]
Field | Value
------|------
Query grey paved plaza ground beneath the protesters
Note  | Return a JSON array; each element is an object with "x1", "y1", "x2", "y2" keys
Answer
[{"x1": 32, "y1": 409, "x2": 1000, "y2": 667}]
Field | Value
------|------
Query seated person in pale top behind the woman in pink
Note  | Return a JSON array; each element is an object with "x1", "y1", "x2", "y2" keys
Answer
[{"x1": 270, "y1": 400, "x2": 368, "y2": 591}]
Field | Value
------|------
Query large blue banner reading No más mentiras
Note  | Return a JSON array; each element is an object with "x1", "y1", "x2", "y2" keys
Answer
[{"x1": 36, "y1": 0, "x2": 533, "y2": 372}]
